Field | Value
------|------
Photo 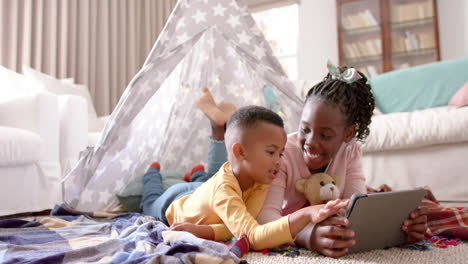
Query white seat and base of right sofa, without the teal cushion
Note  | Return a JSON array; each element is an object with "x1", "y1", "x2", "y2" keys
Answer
[{"x1": 362, "y1": 106, "x2": 468, "y2": 201}]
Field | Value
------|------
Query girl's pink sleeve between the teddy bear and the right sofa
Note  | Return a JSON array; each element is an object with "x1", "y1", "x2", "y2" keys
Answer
[{"x1": 342, "y1": 142, "x2": 367, "y2": 198}]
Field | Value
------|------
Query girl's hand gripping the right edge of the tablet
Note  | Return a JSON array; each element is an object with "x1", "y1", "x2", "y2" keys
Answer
[{"x1": 401, "y1": 207, "x2": 429, "y2": 243}]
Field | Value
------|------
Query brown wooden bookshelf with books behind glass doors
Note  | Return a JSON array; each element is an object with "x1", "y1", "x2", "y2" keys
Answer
[{"x1": 336, "y1": 0, "x2": 440, "y2": 77}]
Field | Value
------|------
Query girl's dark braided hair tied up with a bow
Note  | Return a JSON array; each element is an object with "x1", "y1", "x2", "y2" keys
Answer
[{"x1": 305, "y1": 67, "x2": 375, "y2": 141}]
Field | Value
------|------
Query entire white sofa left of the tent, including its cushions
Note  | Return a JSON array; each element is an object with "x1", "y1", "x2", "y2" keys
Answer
[{"x1": 0, "y1": 66, "x2": 92, "y2": 216}]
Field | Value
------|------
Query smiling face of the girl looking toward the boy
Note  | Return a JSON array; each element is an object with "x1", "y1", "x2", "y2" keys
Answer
[{"x1": 298, "y1": 97, "x2": 355, "y2": 173}]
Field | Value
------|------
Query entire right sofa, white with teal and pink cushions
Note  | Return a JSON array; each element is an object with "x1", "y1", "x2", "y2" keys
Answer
[{"x1": 362, "y1": 58, "x2": 468, "y2": 202}]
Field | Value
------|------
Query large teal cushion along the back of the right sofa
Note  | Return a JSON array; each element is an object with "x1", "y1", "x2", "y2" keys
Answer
[{"x1": 369, "y1": 57, "x2": 468, "y2": 113}]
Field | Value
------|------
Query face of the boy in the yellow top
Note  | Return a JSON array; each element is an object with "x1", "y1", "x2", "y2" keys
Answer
[{"x1": 240, "y1": 122, "x2": 287, "y2": 184}]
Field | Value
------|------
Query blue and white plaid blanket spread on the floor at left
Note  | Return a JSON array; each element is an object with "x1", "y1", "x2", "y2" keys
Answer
[{"x1": 0, "y1": 206, "x2": 240, "y2": 263}]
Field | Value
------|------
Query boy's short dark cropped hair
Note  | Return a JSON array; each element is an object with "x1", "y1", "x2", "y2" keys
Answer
[{"x1": 226, "y1": 105, "x2": 284, "y2": 132}]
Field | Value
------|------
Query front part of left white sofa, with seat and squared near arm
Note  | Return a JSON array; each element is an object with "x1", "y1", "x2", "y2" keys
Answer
[{"x1": 0, "y1": 93, "x2": 62, "y2": 215}]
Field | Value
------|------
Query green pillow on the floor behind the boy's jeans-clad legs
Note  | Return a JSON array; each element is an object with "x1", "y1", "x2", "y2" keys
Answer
[{"x1": 117, "y1": 170, "x2": 184, "y2": 212}]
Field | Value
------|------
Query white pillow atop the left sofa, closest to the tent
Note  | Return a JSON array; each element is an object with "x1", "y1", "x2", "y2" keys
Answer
[{"x1": 23, "y1": 65, "x2": 97, "y2": 124}]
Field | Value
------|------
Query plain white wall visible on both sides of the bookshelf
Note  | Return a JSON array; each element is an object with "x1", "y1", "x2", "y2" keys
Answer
[{"x1": 298, "y1": 0, "x2": 468, "y2": 81}]
